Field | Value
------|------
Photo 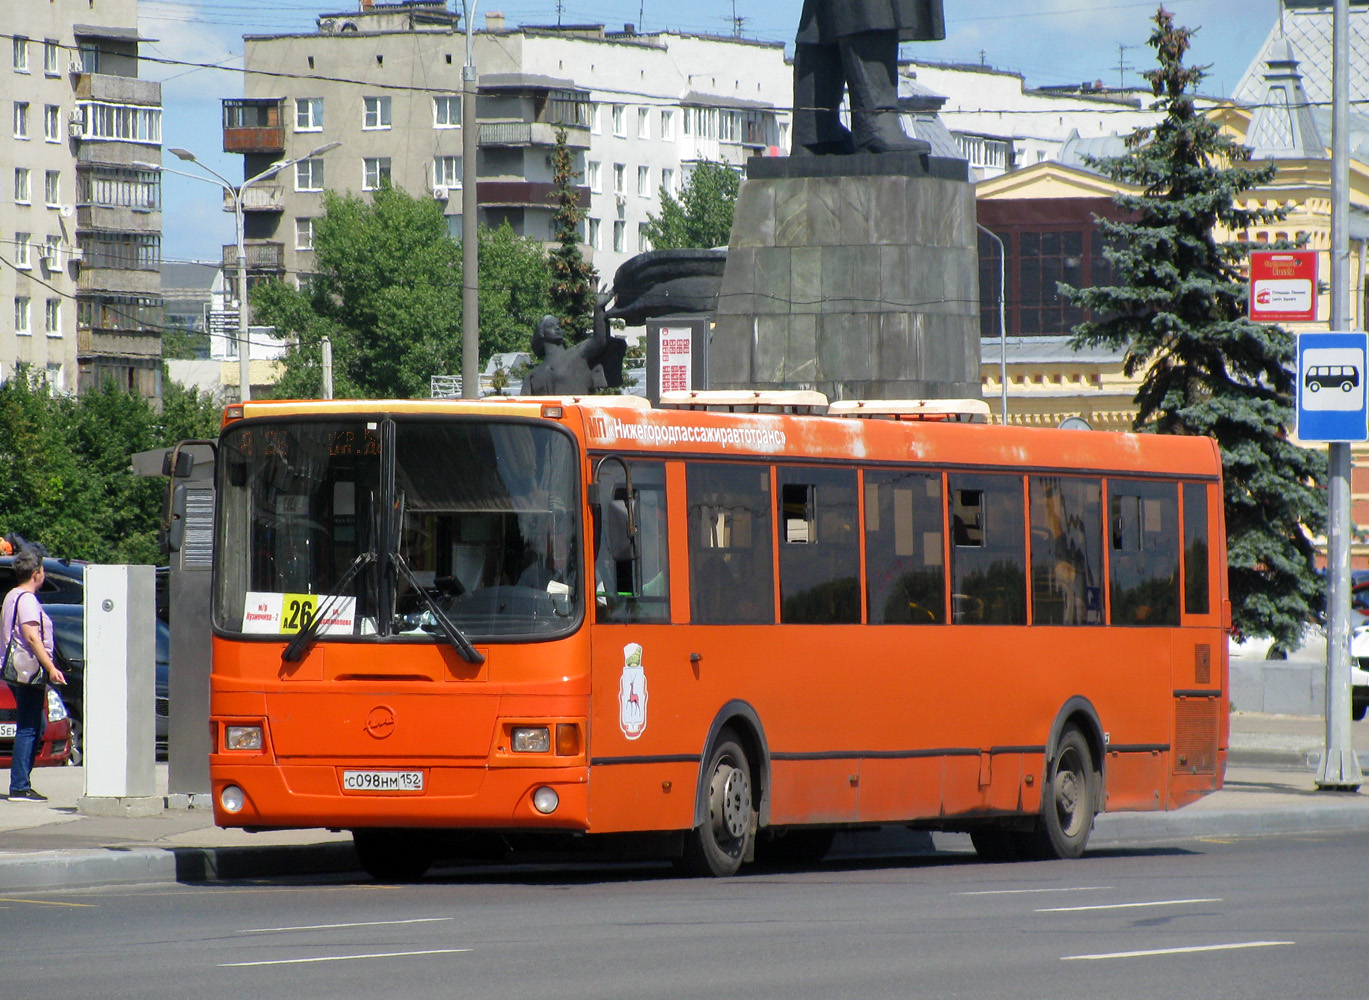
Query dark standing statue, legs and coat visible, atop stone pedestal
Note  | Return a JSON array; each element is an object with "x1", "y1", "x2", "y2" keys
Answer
[{"x1": 793, "y1": 0, "x2": 946, "y2": 156}]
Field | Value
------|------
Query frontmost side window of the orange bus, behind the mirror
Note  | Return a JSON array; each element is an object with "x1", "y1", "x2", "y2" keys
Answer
[{"x1": 594, "y1": 462, "x2": 671, "y2": 622}]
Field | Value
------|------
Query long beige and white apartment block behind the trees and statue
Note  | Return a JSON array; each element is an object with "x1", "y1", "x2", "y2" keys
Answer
[{"x1": 223, "y1": 0, "x2": 793, "y2": 312}]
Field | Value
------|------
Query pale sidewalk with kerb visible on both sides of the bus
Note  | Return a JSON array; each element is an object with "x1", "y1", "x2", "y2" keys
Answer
[{"x1": 0, "y1": 714, "x2": 1369, "y2": 892}]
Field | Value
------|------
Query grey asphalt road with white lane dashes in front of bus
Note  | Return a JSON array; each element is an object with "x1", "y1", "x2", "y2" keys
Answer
[{"x1": 0, "y1": 833, "x2": 1369, "y2": 1000}]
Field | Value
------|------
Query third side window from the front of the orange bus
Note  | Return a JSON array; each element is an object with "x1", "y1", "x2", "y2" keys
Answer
[{"x1": 778, "y1": 468, "x2": 860, "y2": 625}]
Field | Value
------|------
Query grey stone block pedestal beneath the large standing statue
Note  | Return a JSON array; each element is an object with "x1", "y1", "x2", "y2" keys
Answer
[{"x1": 708, "y1": 153, "x2": 980, "y2": 400}]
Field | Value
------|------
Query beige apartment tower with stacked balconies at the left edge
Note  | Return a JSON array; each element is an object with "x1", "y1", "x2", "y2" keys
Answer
[{"x1": 0, "y1": 0, "x2": 162, "y2": 397}]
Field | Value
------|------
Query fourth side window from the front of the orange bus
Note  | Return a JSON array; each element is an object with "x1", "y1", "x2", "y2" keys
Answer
[{"x1": 865, "y1": 471, "x2": 946, "y2": 625}]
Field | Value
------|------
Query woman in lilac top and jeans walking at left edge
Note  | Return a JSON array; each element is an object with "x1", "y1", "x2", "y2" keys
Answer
[{"x1": 0, "y1": 548, "x2": 67, "y2": 803}]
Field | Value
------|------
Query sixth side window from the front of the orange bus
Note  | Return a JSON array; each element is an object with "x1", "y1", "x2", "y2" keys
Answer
[{"x1": 1029, "y1": 475, "x2": 1103, "y2": 625}]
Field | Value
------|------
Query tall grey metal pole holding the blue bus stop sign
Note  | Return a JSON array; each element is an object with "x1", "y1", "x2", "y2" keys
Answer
[{"x1": 1317, "y1": 0, "x2": 1364, "y2": 792}]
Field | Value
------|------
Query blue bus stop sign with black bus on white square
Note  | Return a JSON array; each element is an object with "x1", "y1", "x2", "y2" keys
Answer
[{"x1": 1298, "y1": 330, "x2": 1369, "y2": 441}]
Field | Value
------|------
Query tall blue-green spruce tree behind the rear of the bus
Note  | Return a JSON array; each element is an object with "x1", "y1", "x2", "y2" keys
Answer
[{"x1": 1062, "y1": 8, "x2": 1325, "y2": 645}]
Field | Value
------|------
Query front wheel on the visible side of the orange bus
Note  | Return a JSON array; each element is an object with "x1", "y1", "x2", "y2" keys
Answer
[{"x1": 680, "y1": 729, "x2": 756, "y2": 877}]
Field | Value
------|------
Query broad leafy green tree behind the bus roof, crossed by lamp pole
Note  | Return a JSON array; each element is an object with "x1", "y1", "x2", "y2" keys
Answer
[{"x1": 252, "y1": 188, "x2": 550, "y2": 399}]
